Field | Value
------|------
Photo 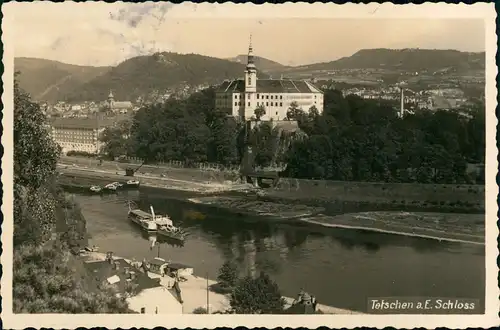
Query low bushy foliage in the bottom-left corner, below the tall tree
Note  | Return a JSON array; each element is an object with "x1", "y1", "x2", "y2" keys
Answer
[{"x1": 13, "y1": 244, "x2": 128, "y2": 314}]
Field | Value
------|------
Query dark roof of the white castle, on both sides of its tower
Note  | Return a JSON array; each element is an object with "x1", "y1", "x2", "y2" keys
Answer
[{"x1": 217, "y1": 79, "x2": 322, "y2": 93}]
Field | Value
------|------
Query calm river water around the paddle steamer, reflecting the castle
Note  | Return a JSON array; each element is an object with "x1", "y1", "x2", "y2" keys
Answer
[{"x1": 75, "y1": 188, "x2": 485, "y2": 312}]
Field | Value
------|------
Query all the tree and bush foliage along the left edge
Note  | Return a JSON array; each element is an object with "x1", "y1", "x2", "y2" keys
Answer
[{"x1": 13, "y1": 73, "x2": 128, "y2": 313}]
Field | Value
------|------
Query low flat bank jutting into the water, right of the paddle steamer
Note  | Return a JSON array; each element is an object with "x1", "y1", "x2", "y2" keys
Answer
[{"x1": 189, "y1": 197, "x2": 485, "y2": 245}]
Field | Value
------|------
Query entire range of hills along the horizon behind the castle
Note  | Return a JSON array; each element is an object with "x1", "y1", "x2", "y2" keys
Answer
[{"x1": 15, "y1": 49, "x2": 485, "y2": 101}]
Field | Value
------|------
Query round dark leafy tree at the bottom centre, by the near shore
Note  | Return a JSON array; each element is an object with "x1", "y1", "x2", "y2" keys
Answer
[{"x1": 230, "y1": 272, "x2": 285, "y2": 314}]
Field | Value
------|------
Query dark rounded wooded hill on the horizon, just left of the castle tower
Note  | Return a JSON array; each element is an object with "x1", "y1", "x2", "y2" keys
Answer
[{"x1": 65, "y1": 52, "x2": 270, "y2": 101}]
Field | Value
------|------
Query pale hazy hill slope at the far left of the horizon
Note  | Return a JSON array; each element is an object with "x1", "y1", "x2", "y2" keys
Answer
[{"x1": 14, "y1": 57, "x2": 111, "y2": 101}]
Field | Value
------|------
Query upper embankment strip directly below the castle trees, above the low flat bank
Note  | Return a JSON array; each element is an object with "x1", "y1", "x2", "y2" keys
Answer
[{"x1": 59, "y1": 159, "x2": 485, "y2": 214}]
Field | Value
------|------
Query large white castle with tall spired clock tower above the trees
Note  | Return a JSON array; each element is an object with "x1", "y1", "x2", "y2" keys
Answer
[{"x1": 215, "y1": 40, "x2": 323, "y2": 121}]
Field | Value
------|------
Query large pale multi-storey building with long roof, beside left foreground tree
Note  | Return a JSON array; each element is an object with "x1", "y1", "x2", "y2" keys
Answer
[{"x1": 50, "y1": 116, "x2": 110, "y2": 154}]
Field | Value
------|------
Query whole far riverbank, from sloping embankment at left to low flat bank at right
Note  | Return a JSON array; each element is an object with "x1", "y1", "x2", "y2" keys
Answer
[{"x1": 61, "y1": 166, "x2": 485, "y2": 245}]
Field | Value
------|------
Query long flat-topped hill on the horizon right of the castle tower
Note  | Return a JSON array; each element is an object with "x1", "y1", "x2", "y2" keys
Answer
[{"x1": 290, "y1": 48, "x2": 485, "y2": 72}]
